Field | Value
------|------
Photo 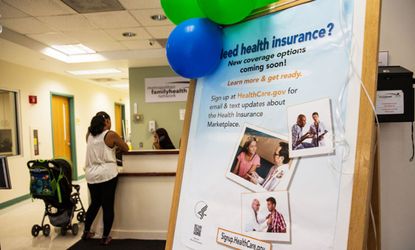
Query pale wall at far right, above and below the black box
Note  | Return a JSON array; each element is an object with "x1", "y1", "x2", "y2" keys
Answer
[{"x1": 380, "y1": 0, "x2": 415, "y2": 250}]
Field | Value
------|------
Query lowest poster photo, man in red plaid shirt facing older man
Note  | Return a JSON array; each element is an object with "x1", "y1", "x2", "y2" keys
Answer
[{"x1": 242, "y1": 191, "x2": 291, "y2": 242}]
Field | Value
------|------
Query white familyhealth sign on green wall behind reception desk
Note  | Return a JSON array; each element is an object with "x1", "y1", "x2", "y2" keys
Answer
[{"x1": 145, "y1": 77, "x2": 189, "y2": 102}]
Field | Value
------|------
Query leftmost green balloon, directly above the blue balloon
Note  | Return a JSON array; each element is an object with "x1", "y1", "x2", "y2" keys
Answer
[{"x1": 161, "y1": 0, "x2": 205, "y2": 24}]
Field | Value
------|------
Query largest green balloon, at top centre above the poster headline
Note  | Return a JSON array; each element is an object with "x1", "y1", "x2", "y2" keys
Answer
[{"x1": 197, "y1": 0, "x2": 255, "y2": 24}]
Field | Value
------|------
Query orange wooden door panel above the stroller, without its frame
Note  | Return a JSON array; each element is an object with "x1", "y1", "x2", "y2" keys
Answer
[{"x1": 52, "y1": 95, "x2": 72, "y2": 161}]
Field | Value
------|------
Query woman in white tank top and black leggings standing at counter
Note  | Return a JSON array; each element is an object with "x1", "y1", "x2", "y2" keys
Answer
[{"x1": 82, "y1": 112, "x2": 128, "y2": 245}]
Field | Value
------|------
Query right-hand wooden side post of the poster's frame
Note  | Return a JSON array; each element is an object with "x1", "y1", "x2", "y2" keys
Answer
[{"x1": 348, "y1": 0, "x2": 381, "y2": 249}]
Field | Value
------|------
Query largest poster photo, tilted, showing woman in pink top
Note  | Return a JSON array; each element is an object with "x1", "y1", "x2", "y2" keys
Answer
[{"x1": 226, "y1": 125, "x2": 296, "y2": 192}]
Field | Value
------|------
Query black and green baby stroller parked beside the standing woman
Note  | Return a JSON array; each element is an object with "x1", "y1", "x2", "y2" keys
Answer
[{"x1": 27, "y1": 159, "x2": 86, "y2": 237}]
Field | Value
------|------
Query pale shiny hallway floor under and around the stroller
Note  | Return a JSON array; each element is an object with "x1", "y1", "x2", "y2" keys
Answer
[{"x1": 0, "y1": 180, "x2": 88, "y2": 250}]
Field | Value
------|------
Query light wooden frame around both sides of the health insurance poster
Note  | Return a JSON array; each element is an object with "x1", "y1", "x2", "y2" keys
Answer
[{"x1": 166, "y1": 0, "x2": 381, "y2": 250}]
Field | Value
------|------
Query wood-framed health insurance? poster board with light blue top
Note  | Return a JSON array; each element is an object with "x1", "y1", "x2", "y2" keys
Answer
[{"x1": 166, "y1": 0, "x2": 380, "y2": 250}]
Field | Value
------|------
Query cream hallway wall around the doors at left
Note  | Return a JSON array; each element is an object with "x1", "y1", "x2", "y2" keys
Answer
[{"x1": 0, "y1": 60, "x2": 129, "y2": 203}]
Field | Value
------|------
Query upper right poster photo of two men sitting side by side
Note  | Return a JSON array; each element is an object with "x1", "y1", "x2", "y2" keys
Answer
[{"x1": 287, "y1": 99, "x2": 334, "y2": 157}]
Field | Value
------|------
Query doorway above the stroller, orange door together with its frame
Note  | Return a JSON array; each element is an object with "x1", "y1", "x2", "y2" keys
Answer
[{"x1": 51, "y1": 93, "x2": 78, "y2": 180}]
